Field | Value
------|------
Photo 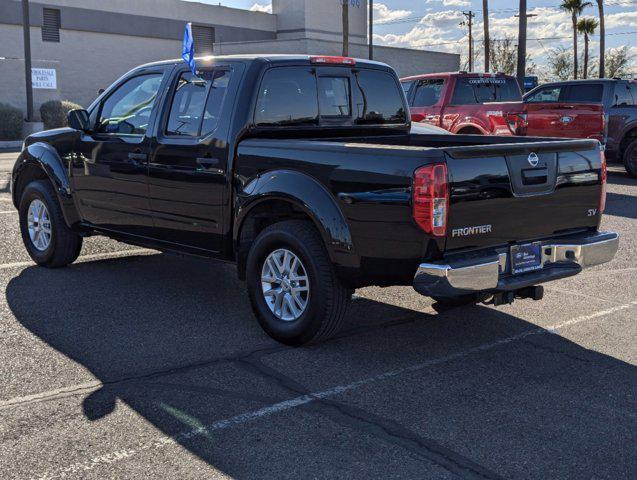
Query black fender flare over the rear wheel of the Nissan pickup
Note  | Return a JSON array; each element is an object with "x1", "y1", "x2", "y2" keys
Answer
[{"x1": 233, "y1": 170, "x2": 360, "y2": 267}]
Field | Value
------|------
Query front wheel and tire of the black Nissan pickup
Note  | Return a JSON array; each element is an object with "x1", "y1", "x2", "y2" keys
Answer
[{"x1": 19, "y1": 180, "x2": 82, "y2": 268}]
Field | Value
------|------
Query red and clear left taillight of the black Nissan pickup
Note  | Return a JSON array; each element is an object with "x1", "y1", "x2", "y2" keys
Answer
[{"x1": 412, "y1": 163, "x2": 449, "y2": 237}]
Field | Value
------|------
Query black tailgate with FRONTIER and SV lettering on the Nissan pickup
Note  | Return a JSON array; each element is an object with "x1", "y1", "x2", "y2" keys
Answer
[{"x1": 444, "y1": 140, "x2": 602, "y2": 251}]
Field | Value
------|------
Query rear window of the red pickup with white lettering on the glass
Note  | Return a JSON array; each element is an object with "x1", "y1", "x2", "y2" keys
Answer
[{"x1": 451, "y1": 77, "x2": 522, "y2": 105}]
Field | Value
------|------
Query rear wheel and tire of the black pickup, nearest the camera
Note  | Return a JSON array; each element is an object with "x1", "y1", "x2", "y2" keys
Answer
[{"x1": 246, "y1": 220, "x2": 352, "y2": 346}]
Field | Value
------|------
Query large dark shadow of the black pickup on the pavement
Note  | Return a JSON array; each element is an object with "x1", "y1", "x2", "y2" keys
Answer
[{"x1": 7, "y1": 255, "x2": 637, "y2": 478}]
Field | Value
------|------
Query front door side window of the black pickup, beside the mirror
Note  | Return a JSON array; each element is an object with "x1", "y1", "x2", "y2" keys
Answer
[{"x1": 95, "y1": 73, "x2": 163, "y2": 135}]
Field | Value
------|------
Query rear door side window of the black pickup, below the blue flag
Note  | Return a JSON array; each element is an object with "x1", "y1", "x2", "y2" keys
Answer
[{"x1": 165, "y1": 69, "x2": 230, "y2": 137}]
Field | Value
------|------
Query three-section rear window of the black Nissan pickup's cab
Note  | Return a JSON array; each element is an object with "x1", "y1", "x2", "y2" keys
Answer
[{"x1": 254, "y1": 67, "x2": 407, "y2": 126}]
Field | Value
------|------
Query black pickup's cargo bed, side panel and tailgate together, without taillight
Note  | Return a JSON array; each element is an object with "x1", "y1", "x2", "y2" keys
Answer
[{"x1": 239, "y1": 134, "x2": 601, "y2": 281}]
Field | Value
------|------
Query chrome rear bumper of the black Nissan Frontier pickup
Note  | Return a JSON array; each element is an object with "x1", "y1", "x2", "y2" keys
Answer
[{"x1": 413, "y1": 232, "x2": 619, "y2": 297}]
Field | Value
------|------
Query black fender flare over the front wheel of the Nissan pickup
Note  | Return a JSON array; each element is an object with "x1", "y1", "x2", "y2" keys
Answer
[{"x1": 11, "y1": 142, "x2": 80, "y2": 226}]
